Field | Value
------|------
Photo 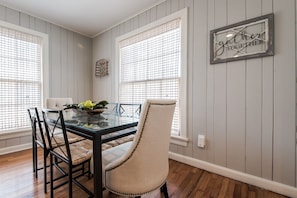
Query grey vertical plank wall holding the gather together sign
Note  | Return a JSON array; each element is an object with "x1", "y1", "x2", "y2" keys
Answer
[{"x1": 93, "y1": 0, "x2": 297, "y2": 187}]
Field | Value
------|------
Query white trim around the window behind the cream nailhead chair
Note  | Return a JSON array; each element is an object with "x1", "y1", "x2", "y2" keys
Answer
[{"x1": 113, "y1": 8, "x2": 188, "y2": 146}]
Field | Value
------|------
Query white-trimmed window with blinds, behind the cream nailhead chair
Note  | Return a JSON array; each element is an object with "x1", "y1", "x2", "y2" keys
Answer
[{"x1": 117, "y1": 10, "x2": 187, "y2": 145}]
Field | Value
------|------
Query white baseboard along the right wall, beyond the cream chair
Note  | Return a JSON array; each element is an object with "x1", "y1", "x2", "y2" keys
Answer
[{"x1": 169, "y1": 152, "x2": 297, "y2": 198}]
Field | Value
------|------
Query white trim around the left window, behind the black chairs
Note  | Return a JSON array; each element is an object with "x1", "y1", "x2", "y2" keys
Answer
[{"x1": 0, "y1": 20, "x2": 49, "y2": 140}]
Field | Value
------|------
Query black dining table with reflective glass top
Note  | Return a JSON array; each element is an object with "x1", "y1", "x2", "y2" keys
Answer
[{"x1": 65, "y1": 112, "x2": 139, "y2": 198}]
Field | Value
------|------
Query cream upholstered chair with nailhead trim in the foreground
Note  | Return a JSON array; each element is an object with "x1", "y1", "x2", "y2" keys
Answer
[{"x1": 102, "y1": 99, "x2": 176, "y2": 197}]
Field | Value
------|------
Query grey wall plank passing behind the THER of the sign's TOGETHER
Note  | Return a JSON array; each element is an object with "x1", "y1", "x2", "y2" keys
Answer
[{"x1": 245, "y1": 0, "x2": 262, "y2": 176}]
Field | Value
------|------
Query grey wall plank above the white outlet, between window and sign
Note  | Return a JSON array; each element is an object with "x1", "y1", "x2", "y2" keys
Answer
[{"x1": 192, "y1": 1, "x2": 206, "y2": 160}]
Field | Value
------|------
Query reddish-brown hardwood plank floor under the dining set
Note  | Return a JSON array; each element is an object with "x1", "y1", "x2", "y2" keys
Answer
[{"x1": 0, "y1": 150, "x2": 285, "y2": 198}]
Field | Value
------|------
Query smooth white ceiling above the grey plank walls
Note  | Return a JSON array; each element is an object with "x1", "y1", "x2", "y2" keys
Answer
[{"x1": 0, "y1": 0, "x2": 164, "y2": 37}]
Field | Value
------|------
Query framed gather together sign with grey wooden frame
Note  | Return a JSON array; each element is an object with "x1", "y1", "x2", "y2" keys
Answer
[{"x1": 210, "y1": 14, "x2": 274, "y2": 64}]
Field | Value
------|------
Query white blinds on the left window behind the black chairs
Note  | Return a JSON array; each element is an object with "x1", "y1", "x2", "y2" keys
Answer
[{"x1": 0, "y1": 26, "x2": 42, "y2": 133}]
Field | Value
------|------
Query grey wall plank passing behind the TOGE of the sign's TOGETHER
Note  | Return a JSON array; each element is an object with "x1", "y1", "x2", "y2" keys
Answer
[{"x1": 227, "y1": 0, "x2": 246, "y2": 171}]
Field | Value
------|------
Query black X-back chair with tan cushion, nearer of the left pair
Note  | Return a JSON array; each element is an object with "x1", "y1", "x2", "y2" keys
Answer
[{"x1": 42, "y1": 109, "x2": 93, "y2": 197}]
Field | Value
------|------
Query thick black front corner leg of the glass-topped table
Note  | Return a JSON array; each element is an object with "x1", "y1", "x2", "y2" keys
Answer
[{"x1": 93, "y1": 134, "x2": 103, "y2": 198}]
